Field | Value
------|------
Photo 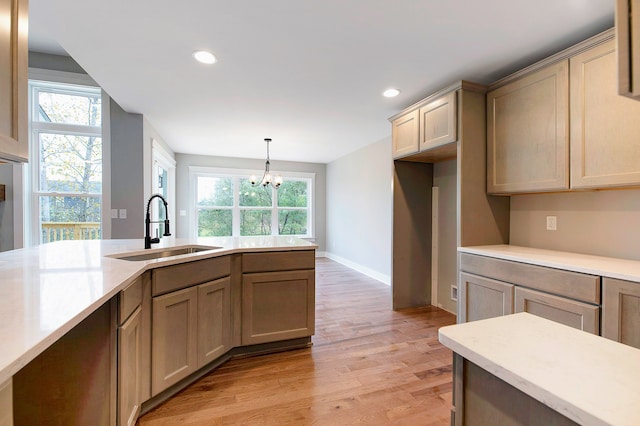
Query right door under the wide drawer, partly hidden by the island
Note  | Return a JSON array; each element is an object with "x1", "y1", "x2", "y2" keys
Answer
[{"x1": 514, "y1": 287, "x2": 600, "y2": 334}]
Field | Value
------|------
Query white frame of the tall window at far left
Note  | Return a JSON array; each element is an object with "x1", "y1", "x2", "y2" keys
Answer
[{"x1": 24, "y1": 68, "x2": 111, "y2": 246}]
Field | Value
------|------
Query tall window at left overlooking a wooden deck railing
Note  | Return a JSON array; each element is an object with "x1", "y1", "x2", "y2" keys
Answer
[{"x1": 29, "y1": 80, "x2": 103, "y2": 243}]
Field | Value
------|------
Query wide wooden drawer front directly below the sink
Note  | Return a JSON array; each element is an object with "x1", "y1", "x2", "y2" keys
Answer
[{"x1": 152, "y1": 256, "x2": 231, "y2": 296}]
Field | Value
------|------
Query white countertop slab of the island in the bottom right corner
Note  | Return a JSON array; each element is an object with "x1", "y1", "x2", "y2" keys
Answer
[{"x1": 439, "y1": 312, "x2": 640, "y2": 425}]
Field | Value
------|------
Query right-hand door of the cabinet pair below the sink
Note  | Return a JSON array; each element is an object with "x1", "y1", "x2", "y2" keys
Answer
[{"x1": 198, "y1": 277, "x2": 231, "y2": 368}]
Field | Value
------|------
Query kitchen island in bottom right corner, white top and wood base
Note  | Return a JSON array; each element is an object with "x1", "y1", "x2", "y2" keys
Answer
[{"x1": 439, "y1": 312, "x2": 640, "y2": 425}]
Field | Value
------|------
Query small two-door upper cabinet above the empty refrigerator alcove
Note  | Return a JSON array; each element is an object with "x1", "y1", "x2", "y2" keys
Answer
[{"x1": 391, "y1": 90, "x2": 458, "y2": 158}]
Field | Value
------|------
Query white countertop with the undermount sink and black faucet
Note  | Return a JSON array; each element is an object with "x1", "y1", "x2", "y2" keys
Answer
[{"x1": 0, "y1": 236, "x2": 317, "y2": 383}]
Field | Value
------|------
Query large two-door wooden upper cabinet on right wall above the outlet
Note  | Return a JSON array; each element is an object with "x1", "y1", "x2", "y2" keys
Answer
[{"x1": 487, "y1": 30, "x2": 640, "y2": 194}]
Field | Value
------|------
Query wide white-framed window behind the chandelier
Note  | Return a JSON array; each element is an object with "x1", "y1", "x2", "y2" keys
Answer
[{"x1": 191, "y1": 167, "x2": 314, "y2": 237}]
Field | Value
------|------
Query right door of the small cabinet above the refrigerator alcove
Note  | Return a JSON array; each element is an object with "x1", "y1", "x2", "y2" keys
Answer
[{"x1": 420, "y1": 92, "x2": 458, "y2": 151}]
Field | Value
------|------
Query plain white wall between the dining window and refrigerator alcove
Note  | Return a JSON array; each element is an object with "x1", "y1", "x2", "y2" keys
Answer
[{"x1": 327, "y1": 137, "x2": 393, "y2": 284}]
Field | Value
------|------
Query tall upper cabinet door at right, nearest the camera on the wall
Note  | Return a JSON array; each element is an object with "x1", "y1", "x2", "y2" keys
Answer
[{"x1": 570, "y1": 40, "x2": 640, "y2": 189}]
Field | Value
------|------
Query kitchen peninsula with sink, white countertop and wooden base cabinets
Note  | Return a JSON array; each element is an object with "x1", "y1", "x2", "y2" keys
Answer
[{"x1": 0, "y1": 236, "x2": 317, "y2": 425}]
